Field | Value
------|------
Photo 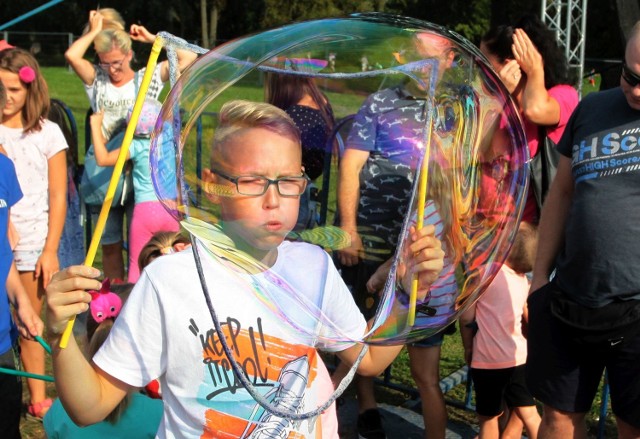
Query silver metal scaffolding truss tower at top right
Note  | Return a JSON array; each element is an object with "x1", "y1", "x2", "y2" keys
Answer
[{"x1": 541, "y1": 0, "x2": 587, "y2": 95}]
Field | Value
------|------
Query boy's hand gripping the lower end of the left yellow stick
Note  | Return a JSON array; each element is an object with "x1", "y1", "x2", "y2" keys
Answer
[{"x1": 46, "y1": 265, "x2": 102, "y2": 335}]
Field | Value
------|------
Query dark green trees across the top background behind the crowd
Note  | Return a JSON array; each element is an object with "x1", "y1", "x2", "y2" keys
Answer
[{"x1": 0, "y1": 0, "x2": 640, "y2": 65}]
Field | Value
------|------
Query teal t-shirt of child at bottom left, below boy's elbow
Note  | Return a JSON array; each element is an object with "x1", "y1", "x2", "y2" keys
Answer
[{"x1": 43, "y1": 393, "x2": 163, "y2": 439}]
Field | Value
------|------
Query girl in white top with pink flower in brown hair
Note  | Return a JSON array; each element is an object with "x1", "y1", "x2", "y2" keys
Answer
[{"x1": 0, "y1": 49, "x2": 67, "y2": 418}]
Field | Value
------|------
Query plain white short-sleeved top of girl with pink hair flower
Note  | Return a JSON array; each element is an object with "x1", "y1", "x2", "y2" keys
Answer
[{"x1": 0, "y1": 119, "x2": 68, "y2": 251}]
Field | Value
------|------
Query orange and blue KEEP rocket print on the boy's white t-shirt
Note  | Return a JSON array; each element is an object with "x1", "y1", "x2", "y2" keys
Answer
[{"x1": 189, "y1": 317, "x2": 321, "y2": 439}]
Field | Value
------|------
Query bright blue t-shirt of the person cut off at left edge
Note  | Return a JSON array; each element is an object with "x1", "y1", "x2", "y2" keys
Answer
[{"x1": 0, "y1": 154, "x2": 22, "y2": 353}]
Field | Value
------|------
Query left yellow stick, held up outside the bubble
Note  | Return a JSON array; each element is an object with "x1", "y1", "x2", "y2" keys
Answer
[{"x1": 60, "y1": 38, "x2": 163, "y2": 349}]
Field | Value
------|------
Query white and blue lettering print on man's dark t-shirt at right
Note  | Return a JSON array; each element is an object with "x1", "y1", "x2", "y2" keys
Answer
[{"x1": 572, "y1": 121, "x2": 640, "y2": 184}]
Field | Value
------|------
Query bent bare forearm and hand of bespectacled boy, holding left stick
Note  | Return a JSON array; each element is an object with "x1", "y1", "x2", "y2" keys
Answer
[{"x1": 47, "y1": 265, "x2": 132, "y2": 425}]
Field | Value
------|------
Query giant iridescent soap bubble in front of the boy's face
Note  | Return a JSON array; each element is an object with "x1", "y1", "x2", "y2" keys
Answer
[{"x1": 151, "y1": 14, "x2": 528, "y2": 346}]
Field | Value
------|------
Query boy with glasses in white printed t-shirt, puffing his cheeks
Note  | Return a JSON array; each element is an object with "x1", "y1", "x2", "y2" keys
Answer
[{"x1": 47, "y1": 101, "x2": 444, "y2": 438}]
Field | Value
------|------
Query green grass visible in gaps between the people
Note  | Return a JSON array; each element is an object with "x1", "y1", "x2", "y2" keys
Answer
[{"x1": 27, "y1": 67, "x2": 616, "y2": 438}]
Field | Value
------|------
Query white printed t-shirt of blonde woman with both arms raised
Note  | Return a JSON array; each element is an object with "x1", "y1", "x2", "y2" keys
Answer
[{"x1": 84, "y1": 64, "x2": 164, "y2": 139}]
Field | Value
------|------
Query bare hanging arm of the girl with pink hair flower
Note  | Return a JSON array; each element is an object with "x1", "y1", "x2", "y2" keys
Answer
[{"x1": 35, "y1": 150, "x2": 67, "y2": 288}]
